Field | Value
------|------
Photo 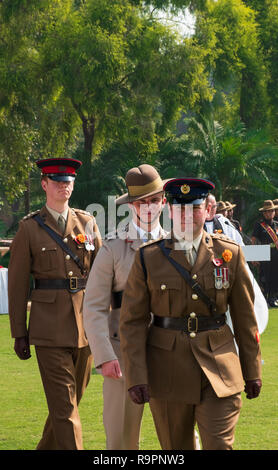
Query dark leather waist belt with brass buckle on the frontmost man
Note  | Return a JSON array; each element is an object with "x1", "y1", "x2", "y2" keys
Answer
[{"x1": 153, "y1": 313, "x2": 226, "y2": 336}]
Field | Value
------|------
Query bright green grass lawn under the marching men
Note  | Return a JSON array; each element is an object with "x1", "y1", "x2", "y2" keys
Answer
[{"x1": 0, "y1": 309, "x2": 278, "y2": 450}]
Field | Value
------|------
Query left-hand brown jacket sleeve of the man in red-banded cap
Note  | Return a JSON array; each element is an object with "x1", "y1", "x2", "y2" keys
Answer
[{"x1": 8, "y1": 222, "x2": 31, "y2": 338}]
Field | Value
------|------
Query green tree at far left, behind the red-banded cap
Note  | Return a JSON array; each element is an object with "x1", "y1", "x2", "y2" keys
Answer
[{"x1": 0, "y1": 0, "x2": 78, "y2": 207}]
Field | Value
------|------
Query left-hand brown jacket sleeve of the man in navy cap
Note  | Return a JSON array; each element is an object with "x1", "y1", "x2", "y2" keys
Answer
[{"x1": 120, "y1": 251, "x2": 151, "y2": 389}]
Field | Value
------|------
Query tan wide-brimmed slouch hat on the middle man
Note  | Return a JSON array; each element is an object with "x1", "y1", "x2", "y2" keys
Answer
[{"x1": 116, "y1": 163, "x2": 163, "y2": 206}]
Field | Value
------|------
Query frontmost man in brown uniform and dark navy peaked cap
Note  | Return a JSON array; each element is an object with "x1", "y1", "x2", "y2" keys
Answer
[{"x1": 120, "y1": 178, "x2": 261, "y2": 450}]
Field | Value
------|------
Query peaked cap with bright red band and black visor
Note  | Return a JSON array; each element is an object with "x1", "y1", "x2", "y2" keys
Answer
[{"x1": 36, "y1": 158, "x2": 82, "y2": 181}]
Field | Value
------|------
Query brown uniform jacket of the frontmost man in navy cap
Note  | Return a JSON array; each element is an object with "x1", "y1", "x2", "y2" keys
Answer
[{"x1": 120, "y1": 232, "x2": 261, "y2": 403}]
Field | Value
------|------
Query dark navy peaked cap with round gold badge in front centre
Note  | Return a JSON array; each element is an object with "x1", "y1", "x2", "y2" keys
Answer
[{"x1": 164, "y1": 178, "x2": 215, "y2": 205}]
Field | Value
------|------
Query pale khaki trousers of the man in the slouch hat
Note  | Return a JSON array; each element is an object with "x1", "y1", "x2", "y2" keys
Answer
[{"x1": 103, "y1": 340, "x2": 144, "y2": 450}]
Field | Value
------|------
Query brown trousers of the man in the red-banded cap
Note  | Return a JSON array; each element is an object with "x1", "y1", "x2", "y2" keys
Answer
[{"x1": 35, "y1": 346, "x2": 92, "y2": 450}]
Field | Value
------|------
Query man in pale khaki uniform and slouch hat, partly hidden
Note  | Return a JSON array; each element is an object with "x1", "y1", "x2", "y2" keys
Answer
[{"x1": 84, "y1": 165, "x2": 165, "y2": 450}]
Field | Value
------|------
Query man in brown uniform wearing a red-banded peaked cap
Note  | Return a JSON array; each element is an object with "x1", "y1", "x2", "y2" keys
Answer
[{"x1": 8, "y1": 159, "x2": 101, "y2": 450}]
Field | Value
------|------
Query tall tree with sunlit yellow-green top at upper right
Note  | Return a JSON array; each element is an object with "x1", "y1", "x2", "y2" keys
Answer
[{"x1": 196, "y1": 0, "x2": 269, "y2": 128}]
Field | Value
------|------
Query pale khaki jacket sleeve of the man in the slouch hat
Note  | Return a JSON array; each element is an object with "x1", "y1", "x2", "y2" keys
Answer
[{"x1": 83, "y1": 244, "x2": 117, "y2": 367}]
